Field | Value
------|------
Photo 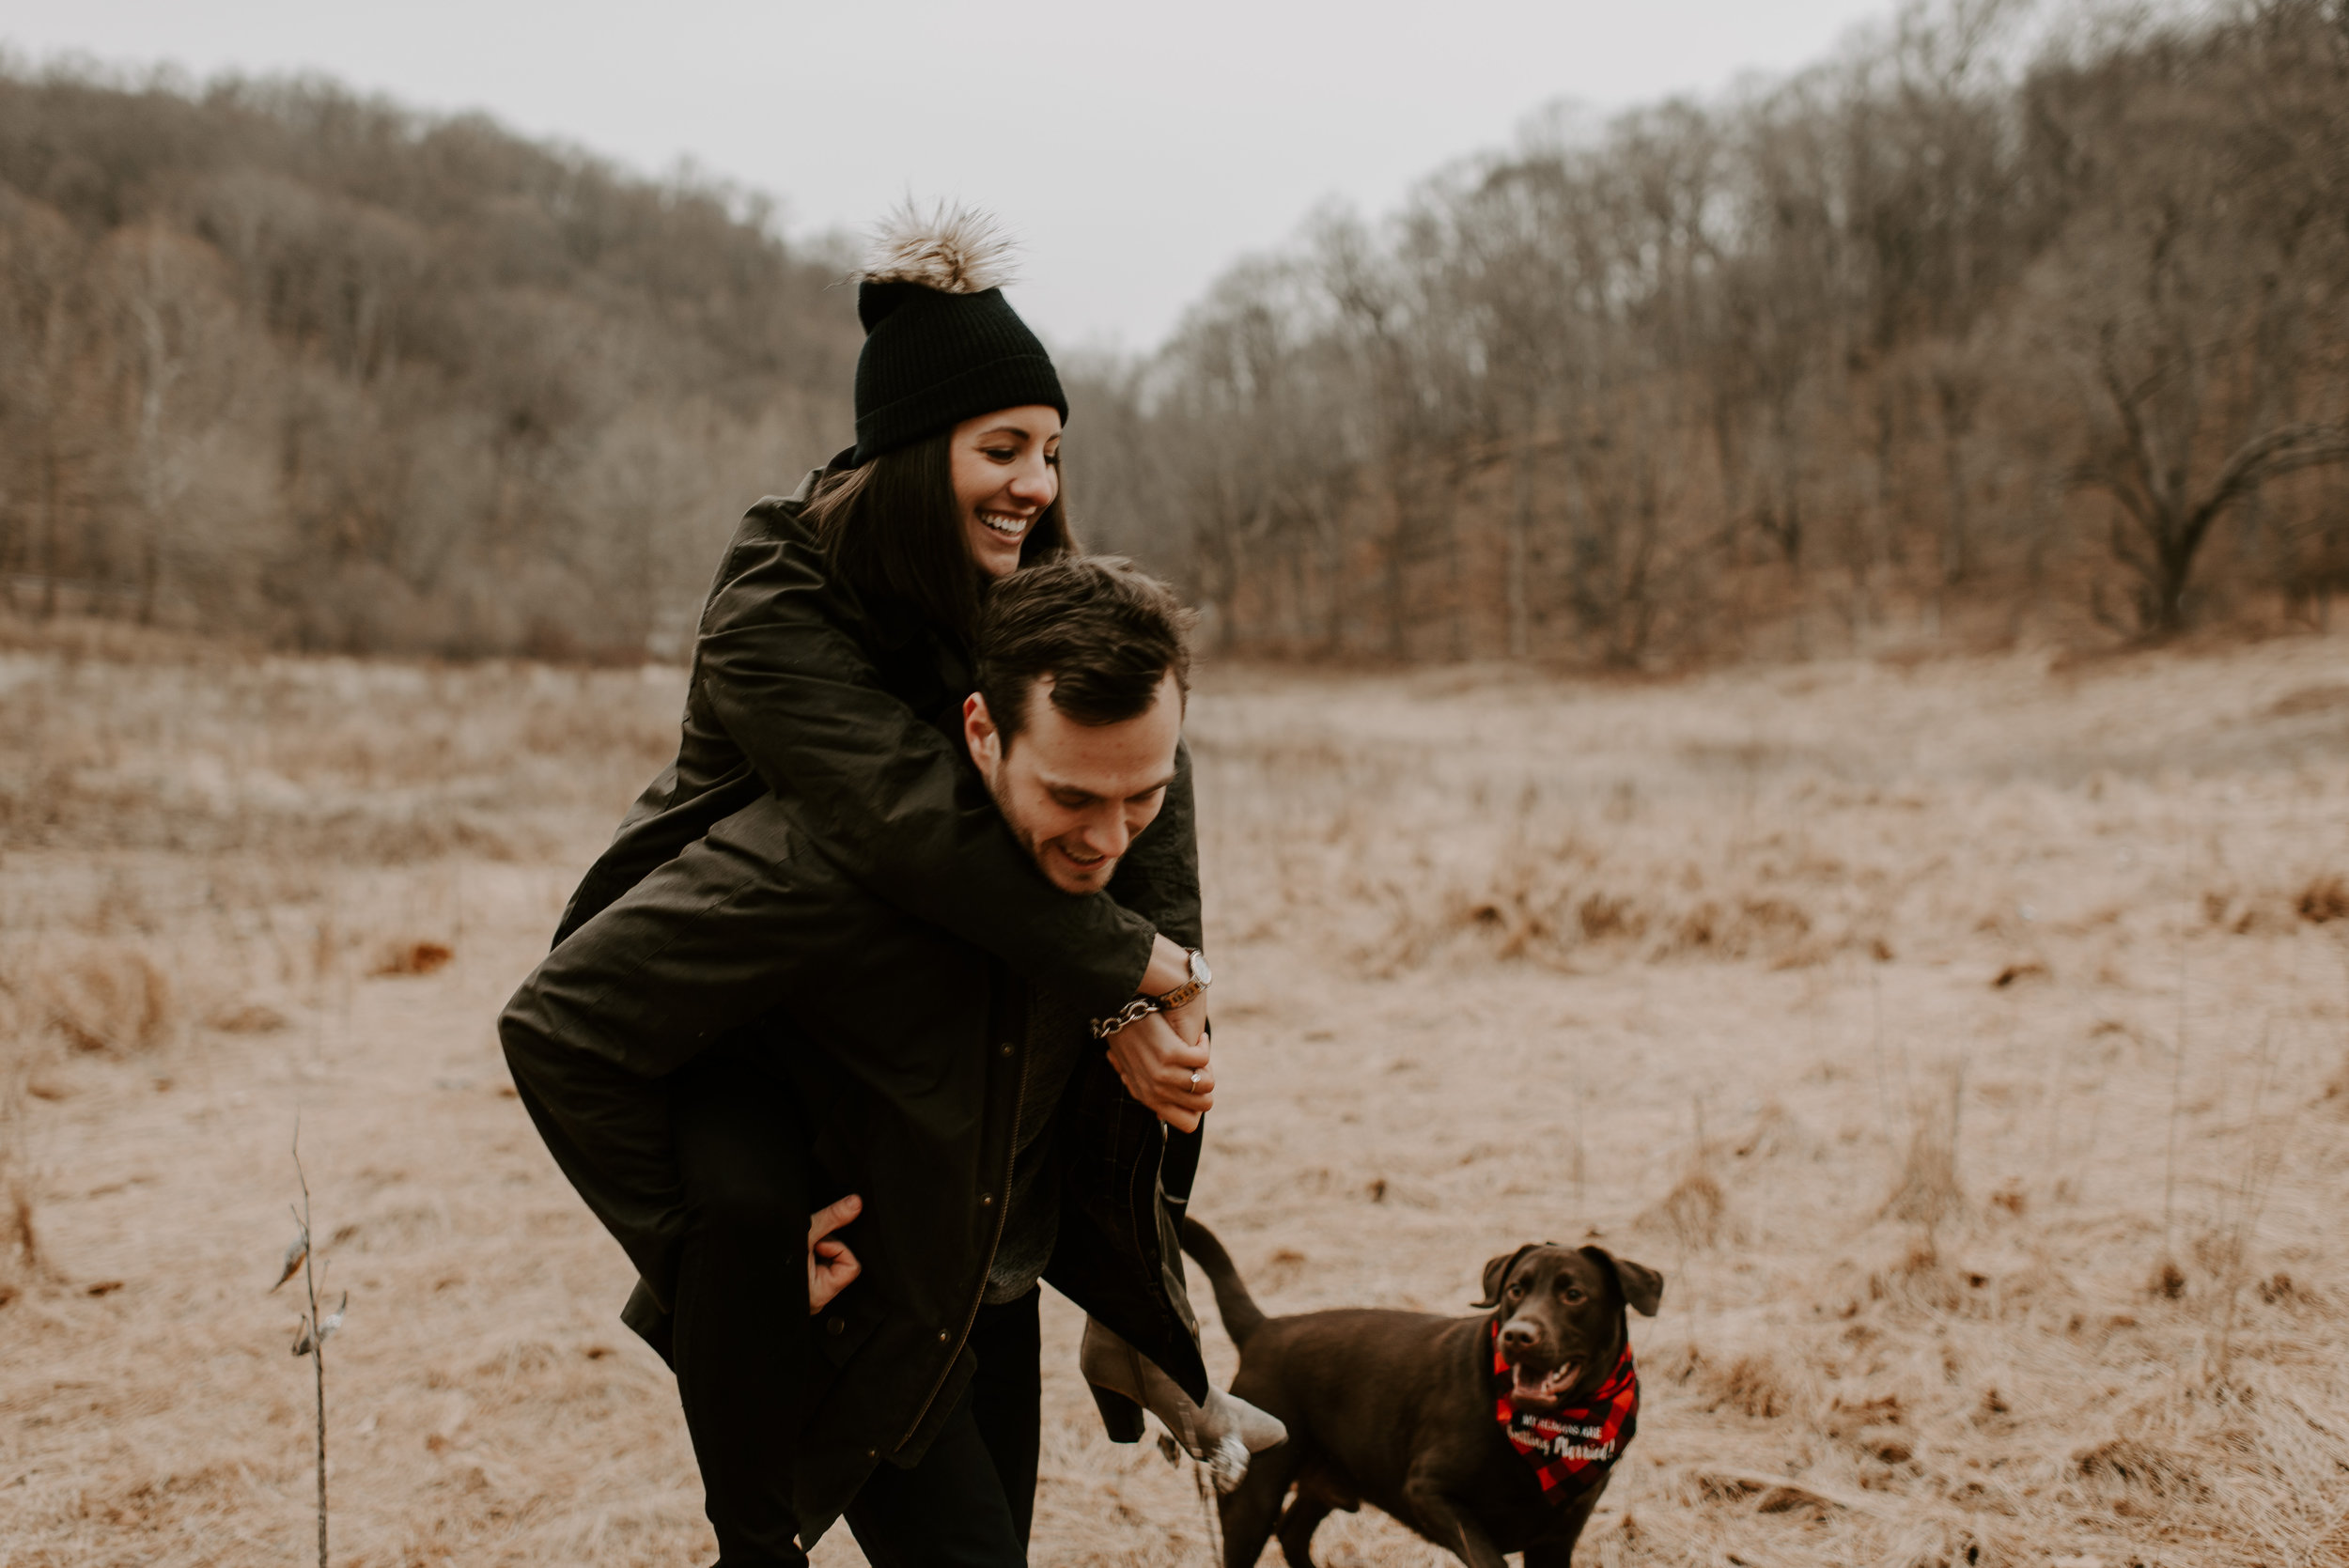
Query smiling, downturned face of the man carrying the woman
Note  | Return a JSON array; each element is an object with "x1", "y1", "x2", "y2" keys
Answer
[{"x1": 963, "y1": 674, "x2": 1182, "y2": 892}]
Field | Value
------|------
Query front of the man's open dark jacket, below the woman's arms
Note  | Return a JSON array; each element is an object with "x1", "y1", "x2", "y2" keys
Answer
[{"x1": 672, "y1": 802, "x2": 1207, "y2": 1545}]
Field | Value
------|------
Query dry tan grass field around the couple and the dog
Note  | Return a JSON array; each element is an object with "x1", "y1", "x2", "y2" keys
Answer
[{"x1": 0, "y1": 629, "x2": 2349, "y2": 1568}]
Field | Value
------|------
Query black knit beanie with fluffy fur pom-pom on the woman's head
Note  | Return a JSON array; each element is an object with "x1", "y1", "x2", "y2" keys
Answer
[{"x1": 855, "y1": 207, "x2": 1069, "y2": 462}]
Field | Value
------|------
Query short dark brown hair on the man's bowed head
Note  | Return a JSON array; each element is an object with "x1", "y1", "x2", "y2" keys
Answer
[{"x1": 977, "y1": 556, "x2": 1191, "y2": 749}]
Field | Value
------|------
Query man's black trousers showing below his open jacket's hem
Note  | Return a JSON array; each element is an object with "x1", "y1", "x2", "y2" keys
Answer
[{"x1": 848, "y1": 1291, "x2": 1043, "y2": 1568}]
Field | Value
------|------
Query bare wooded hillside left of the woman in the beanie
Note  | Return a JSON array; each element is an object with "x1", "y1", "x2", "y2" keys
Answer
[{"x1": 0, "y1": 72, "x2": 860, "y2": 658}]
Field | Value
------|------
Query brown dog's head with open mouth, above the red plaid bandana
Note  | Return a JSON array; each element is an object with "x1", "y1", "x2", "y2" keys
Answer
[{"x1": 1475, "y1": 1242, "x2": 1663, "y2": 1411}]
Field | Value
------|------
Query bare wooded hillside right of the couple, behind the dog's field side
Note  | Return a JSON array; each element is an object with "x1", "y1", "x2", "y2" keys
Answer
[{"x1": 1071, "y1": 0, "x2": 2349, "y2": 664}]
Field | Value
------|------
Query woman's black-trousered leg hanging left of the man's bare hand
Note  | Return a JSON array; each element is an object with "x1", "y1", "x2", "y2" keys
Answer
[{"x1": 670, "y1": 1049, "x2": 808, "y2": 1568}]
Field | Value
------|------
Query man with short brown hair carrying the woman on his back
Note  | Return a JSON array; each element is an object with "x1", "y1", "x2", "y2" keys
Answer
[{"x1": 775, "y1": 561, "x2": 1206, "y2": 1568}]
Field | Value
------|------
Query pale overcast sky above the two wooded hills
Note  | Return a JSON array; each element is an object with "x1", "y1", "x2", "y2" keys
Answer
[{"x1": 0, "y1": 0, "x2": 1891, "y2": 349}]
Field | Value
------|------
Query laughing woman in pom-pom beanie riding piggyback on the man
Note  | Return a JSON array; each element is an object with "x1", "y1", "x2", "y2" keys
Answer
[{"x1": 501, "y1": 213, "x2": 1215, "y2": 1566}]
